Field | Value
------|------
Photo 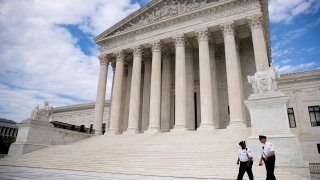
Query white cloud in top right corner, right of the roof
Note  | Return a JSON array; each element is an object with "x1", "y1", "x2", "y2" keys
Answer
[{"x1": 269, "y1": 0, "x2": 320, "y2": 23}]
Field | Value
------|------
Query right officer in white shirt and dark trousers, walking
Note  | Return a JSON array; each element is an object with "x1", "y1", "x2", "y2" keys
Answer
[{"x1": 259, "y1": 135, "x2": 276, "y2": 180}]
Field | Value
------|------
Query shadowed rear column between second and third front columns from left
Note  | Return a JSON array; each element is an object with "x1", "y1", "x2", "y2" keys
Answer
[{"x1": 123, "y1": 62, "x2": 132, "y2": 131}]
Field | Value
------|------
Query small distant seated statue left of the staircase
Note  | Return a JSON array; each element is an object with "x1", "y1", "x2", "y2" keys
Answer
[{"x1": 31, "y1": 101, "x2": 53, "y2": 121}]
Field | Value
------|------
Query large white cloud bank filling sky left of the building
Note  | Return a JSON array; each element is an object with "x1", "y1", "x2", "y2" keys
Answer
[{"x1": 0, "y1": 0, "x2": 139, "y2": 121}]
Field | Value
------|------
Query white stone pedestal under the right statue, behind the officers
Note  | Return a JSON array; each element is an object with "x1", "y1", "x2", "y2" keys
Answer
[{"x1": 245, "y1": 91, "x2": 310, "y2": 179}]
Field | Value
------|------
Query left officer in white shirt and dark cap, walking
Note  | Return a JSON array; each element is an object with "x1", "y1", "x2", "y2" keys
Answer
[{"x1": 237, "y1": 141, "x2": 253, "y2": 180}]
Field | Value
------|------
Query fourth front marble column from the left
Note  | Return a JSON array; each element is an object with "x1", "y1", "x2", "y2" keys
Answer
[{"x1": 147, "y1": 41, "x2": 161, "y2": 132}]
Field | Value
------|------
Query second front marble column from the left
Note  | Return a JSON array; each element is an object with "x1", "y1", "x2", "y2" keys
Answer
[{"x1": 108, "y1": 51, "x2": 125, "y2": 134}]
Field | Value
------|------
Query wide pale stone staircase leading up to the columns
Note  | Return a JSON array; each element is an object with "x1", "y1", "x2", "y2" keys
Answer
[{"x1": 0, "y1": 129, "x2": 304, "y2": 180}]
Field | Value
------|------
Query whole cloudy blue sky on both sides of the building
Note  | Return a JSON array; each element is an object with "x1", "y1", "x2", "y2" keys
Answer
[{"x1": 0, "y1": 0, "x2": 320, "y2": 121}]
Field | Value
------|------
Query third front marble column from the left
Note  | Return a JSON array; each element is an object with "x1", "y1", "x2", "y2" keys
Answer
[{"x1": 127, "y1": 46, "x2": 142, "y2": 133}]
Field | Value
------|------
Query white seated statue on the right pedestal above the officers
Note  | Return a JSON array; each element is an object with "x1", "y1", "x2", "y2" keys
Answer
[{"x1": 247, "y1": 64, "x2": 279, "y2": 94}]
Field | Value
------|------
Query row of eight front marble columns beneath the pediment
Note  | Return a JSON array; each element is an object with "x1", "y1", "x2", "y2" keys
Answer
[{"x1": 95, "y1": 16, "x2": 268, "y2": 134}]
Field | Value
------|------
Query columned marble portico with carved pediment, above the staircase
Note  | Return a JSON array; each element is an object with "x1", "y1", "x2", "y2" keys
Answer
[{"x1": 94, "y1": 0, "x2": 270, "y2": 134}]
